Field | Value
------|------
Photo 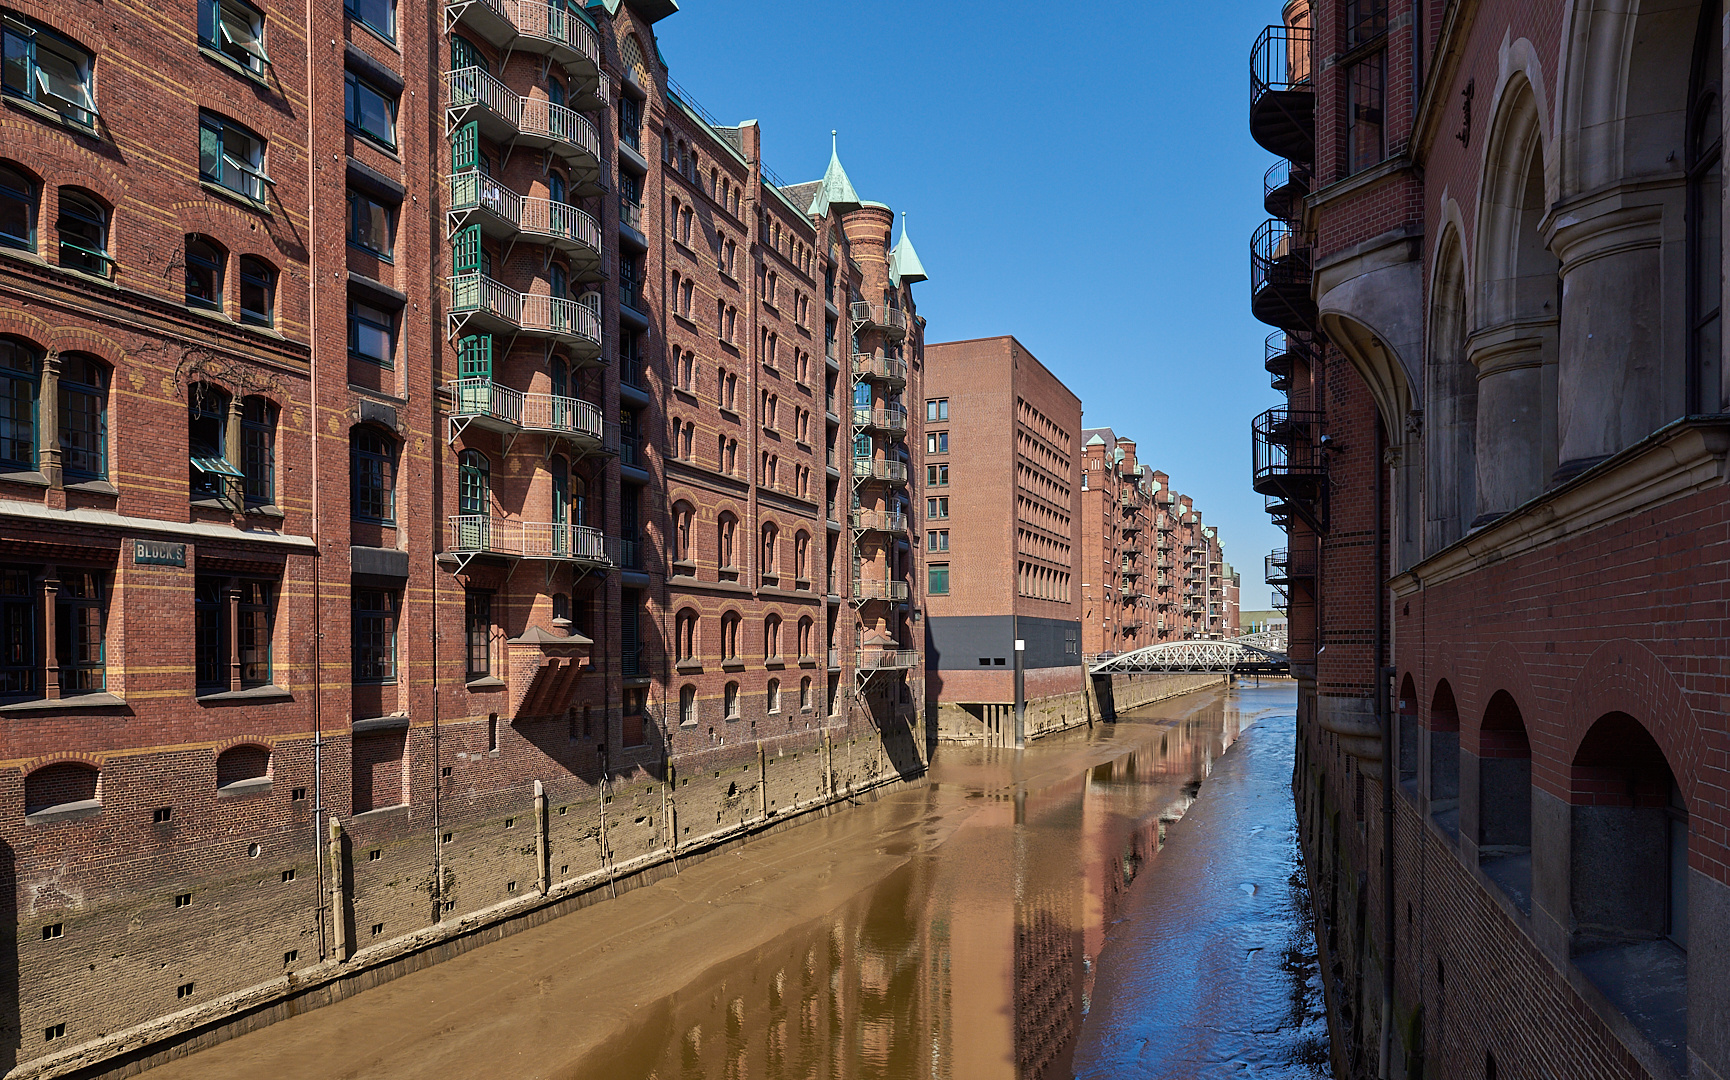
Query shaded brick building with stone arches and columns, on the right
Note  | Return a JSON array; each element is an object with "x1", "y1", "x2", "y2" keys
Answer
[{"x1": 1251, "y1": 0, "x2": 1730, "y2": 1080}]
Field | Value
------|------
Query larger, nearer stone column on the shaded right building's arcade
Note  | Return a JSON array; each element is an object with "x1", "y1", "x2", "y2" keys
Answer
[{"x1": 1548, "y1": 190, "x2": 1682, "y2": 483}]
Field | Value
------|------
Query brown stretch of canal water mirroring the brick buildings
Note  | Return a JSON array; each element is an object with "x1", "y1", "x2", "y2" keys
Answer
[{"x1": 573, "y1": 689, "x2": 1304, "y2": 1080}]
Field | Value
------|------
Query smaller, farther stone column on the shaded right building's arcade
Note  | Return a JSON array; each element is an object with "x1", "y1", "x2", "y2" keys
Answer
[{"x1": 1467, "y1": 320, "x2": 1555, "y2": 526}]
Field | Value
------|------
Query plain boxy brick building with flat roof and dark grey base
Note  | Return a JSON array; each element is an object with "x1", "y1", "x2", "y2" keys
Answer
[{"x1": 924, "y1": 338, "x2": 1086, "y2": 744}]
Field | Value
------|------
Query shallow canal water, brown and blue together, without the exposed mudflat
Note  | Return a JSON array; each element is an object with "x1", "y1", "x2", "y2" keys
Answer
[{"x1": 574, "y1": 684, "x2": 1327, "y2": 1080}]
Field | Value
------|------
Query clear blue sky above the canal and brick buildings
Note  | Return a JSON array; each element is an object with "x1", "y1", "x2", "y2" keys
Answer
[{"x1": 656, "y1": 0, "x2": 1284, "y2": 608}]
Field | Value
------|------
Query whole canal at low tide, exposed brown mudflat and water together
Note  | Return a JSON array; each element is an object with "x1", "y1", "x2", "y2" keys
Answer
[{"x1": 151, "y1": 682, "x2": 1325, "y2": 1080}]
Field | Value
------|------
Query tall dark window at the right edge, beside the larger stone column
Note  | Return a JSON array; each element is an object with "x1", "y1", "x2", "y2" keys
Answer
[{"x1": 1687, "y1": 0, "x2": 1727, "y2": 412}]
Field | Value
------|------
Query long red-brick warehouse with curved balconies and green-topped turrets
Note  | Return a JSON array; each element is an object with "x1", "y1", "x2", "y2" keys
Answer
[{"x1": 0, "y1": 0, "x2": 924, "y2": 1071}]
